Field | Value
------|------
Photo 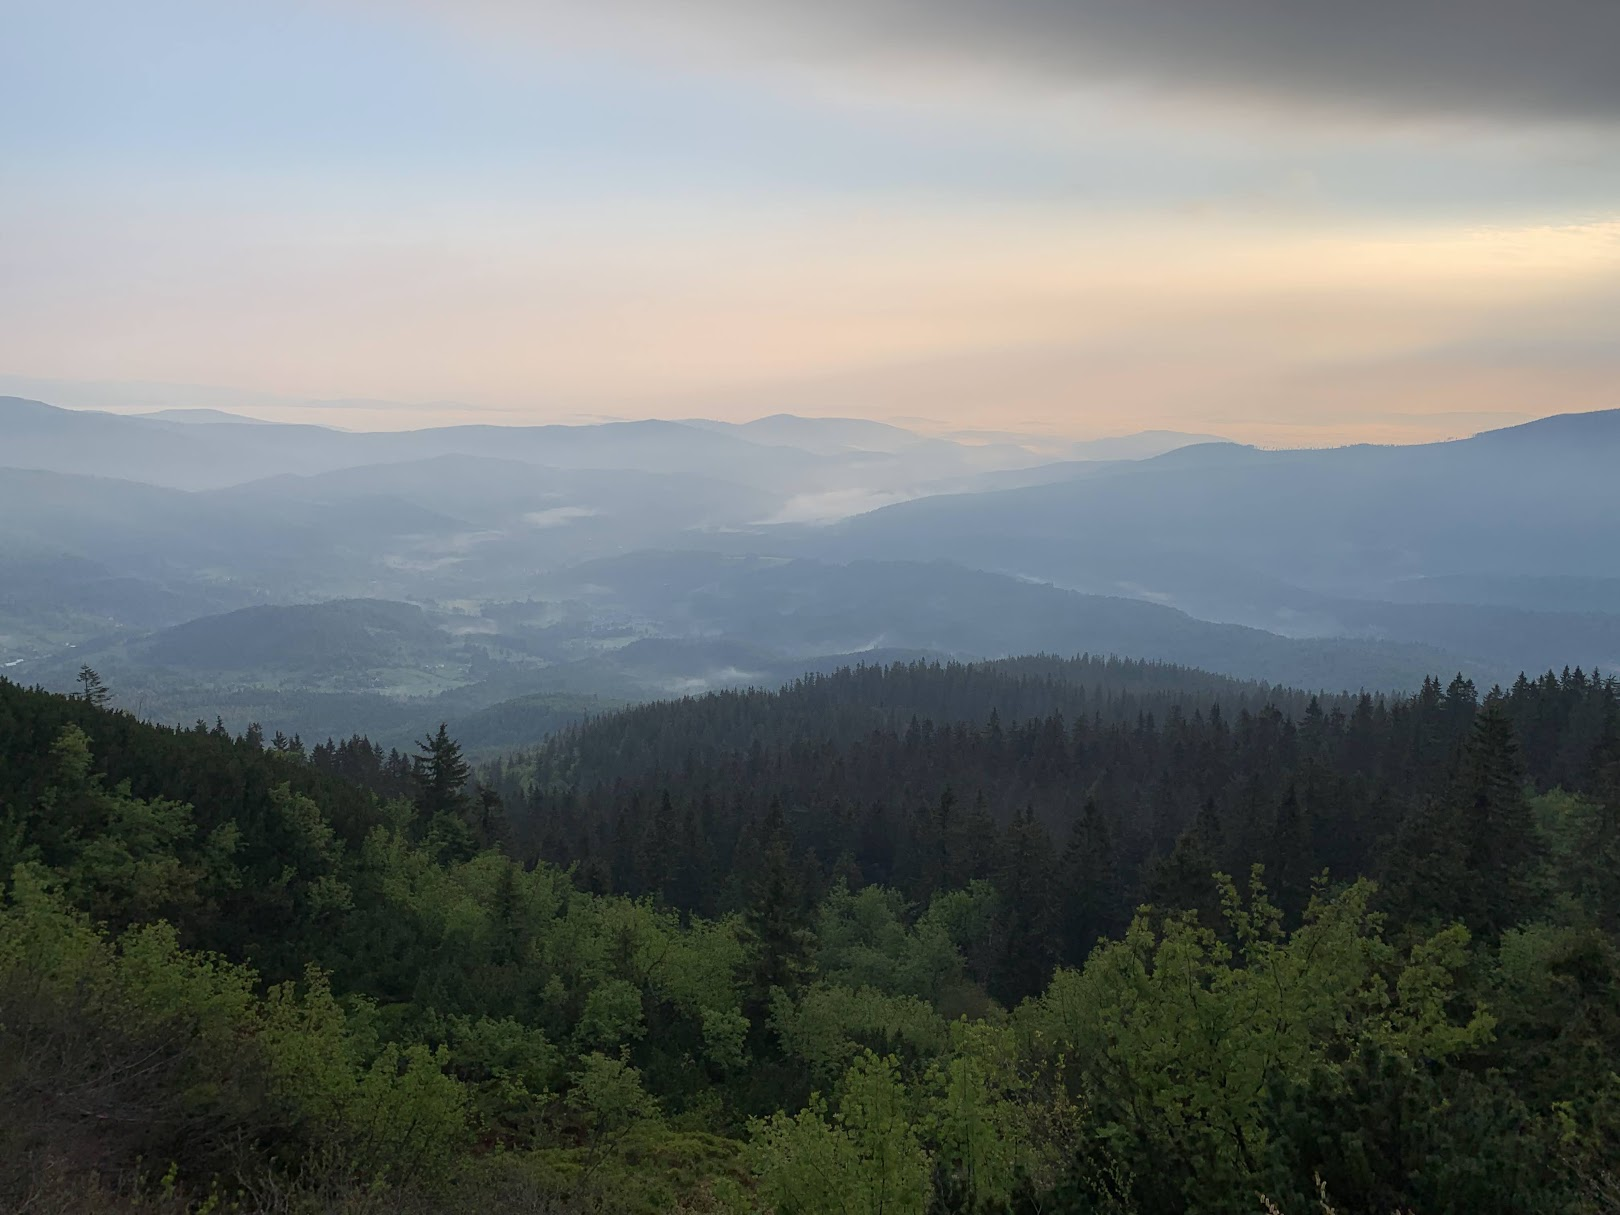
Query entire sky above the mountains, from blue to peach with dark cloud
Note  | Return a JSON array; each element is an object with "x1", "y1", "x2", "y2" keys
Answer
[{"x1": 0, "y1": 0, "x2": 1620, "y2": 446}]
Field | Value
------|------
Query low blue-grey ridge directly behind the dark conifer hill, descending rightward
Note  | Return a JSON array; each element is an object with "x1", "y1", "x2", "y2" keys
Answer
[{"x1": 538, "y1": 552, "x2": 1483, "y2": 690}]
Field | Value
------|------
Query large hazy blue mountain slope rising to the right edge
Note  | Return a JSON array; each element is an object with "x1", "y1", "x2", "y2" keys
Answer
[{"x1": 806, "y1": 411, "x2": 1620, "y2": 619}]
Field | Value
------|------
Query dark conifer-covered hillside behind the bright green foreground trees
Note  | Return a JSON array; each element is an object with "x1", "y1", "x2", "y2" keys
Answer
[{"x1": 492, "y1": 658, "x2": 1615, "y2": 952}]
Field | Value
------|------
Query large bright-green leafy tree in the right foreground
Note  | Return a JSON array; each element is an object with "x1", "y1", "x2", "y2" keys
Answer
[{"x1": 1017, "y1": 878, "x2": 1492, "y2": 1210}]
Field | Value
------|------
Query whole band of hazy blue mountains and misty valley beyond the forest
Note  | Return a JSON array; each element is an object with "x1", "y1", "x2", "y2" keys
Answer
[{"x1": 0, "y1": 399, "x2": 1620, "y2": 748}]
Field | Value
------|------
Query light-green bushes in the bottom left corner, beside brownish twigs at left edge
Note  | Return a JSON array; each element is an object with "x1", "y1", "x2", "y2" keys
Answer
[{"x1": 0, "y1": 868, "x2": 467, "y2": 1181}]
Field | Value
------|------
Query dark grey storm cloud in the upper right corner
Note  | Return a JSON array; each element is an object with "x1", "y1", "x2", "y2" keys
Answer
[{"x1": 719, "y1": 0, "x2": 1620, "y2": 125}]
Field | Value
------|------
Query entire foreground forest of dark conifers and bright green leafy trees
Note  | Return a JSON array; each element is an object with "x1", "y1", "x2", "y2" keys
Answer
[{"x1": 0, "y1": 658, "x2": 1620, "y2": 1215}]
